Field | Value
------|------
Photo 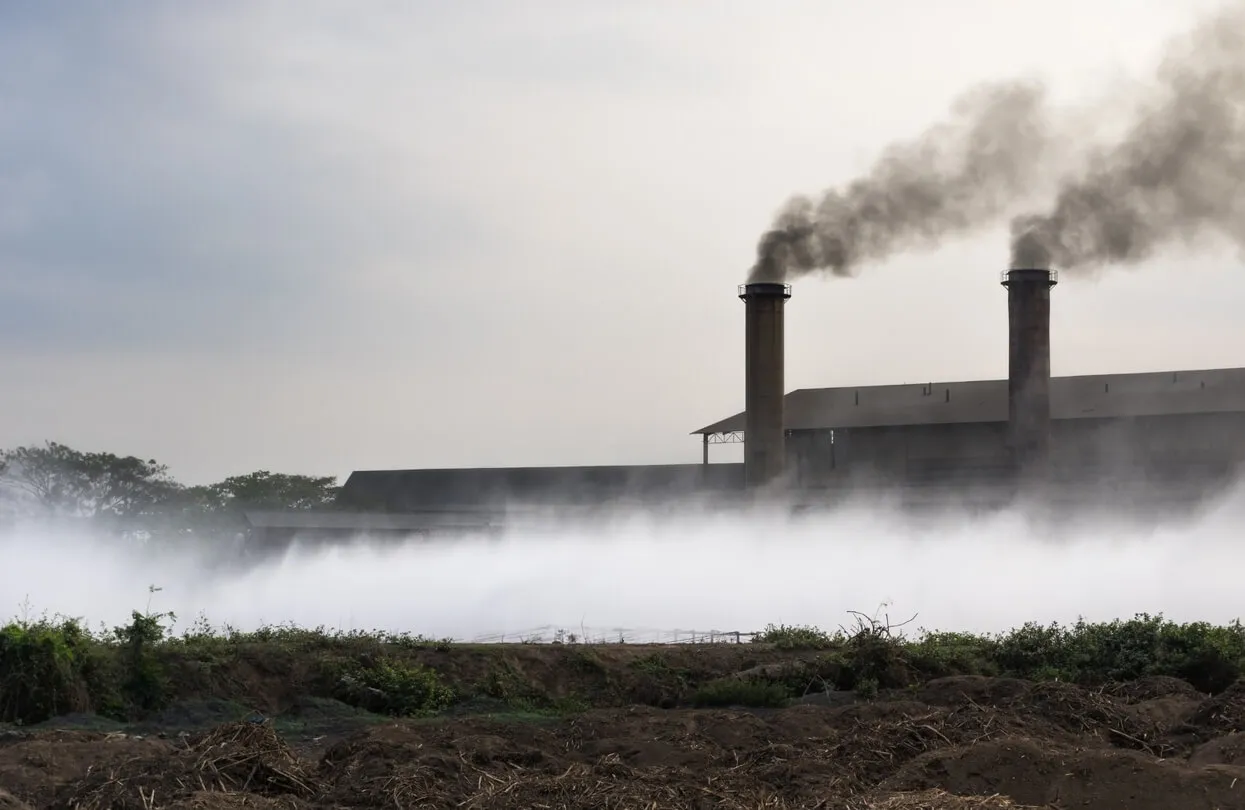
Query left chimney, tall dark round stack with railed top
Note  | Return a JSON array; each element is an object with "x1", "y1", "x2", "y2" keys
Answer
[{"x1": 740, "y1": 282, "x2": 791, "y2": 489}]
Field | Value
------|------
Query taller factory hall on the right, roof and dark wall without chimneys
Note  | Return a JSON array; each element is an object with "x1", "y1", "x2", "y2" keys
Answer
[{"x1": 693, "y1": 368, "x2": 1245, "y2": 489}]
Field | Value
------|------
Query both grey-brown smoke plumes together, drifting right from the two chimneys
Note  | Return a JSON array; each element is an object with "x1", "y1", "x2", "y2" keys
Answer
[{"x1": 749, "y1": 1, "x2": 1245, "y2": 281}]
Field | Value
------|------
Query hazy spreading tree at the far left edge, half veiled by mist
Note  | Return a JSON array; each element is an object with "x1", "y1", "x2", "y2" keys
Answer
[{"x1": 0, "y1": 442, "x2": 181, "y2": 519}]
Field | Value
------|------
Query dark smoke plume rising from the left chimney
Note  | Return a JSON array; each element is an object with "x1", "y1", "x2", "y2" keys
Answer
[{"x1": 748, "y1": 82, "x2": 1051, "y2": 281}]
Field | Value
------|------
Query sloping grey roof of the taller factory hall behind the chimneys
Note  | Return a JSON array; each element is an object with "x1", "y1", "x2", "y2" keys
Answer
[{"x1": 692, "y1": 368, "x2": 1245, "y2": 434}]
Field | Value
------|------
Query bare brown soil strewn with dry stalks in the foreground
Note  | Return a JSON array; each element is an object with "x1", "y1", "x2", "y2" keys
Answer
[{"x1": 0, "y1": 646, "x2": 1245, "y2": 810}]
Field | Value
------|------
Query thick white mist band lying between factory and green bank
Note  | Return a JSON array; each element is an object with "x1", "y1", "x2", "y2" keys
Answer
[{"x1": 0, "y1": 489, "x2": 1245, "y2": 642}]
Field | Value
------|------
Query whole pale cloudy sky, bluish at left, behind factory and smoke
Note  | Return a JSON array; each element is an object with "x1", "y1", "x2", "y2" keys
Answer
[{"x1": 0, "y1": 0, "x2": 1245, "y2": 482}]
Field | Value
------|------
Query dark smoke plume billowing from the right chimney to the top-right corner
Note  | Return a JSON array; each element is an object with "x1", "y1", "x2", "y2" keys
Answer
[{"x1": 1011, "y1": 2, "x2": 1245, "y2": 270}]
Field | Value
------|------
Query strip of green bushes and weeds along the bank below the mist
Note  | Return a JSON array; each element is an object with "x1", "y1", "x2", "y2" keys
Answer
[{"x1": 0, "y1": 602, "x2": 1245, "y2": 727}]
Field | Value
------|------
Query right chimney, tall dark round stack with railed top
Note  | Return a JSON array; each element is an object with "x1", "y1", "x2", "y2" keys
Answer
[{"x1": 1002, "y1": 269, "x2": 1058, "y2": 475}]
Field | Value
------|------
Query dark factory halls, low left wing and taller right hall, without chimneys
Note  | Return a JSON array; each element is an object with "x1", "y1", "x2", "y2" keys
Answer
[{"x1": 328, "y1": 368, "x2": 1245, "y2": 520}]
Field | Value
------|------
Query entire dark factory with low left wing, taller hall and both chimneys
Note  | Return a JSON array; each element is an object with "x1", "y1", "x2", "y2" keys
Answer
[{"x1": 240, "y1": 269, "x2": 1245, "y2": 540}]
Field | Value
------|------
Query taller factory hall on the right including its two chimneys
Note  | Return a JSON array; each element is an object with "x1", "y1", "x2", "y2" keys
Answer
[{"x1": 695, "y1": 269, "x2": 1245, "y2": 490}]
